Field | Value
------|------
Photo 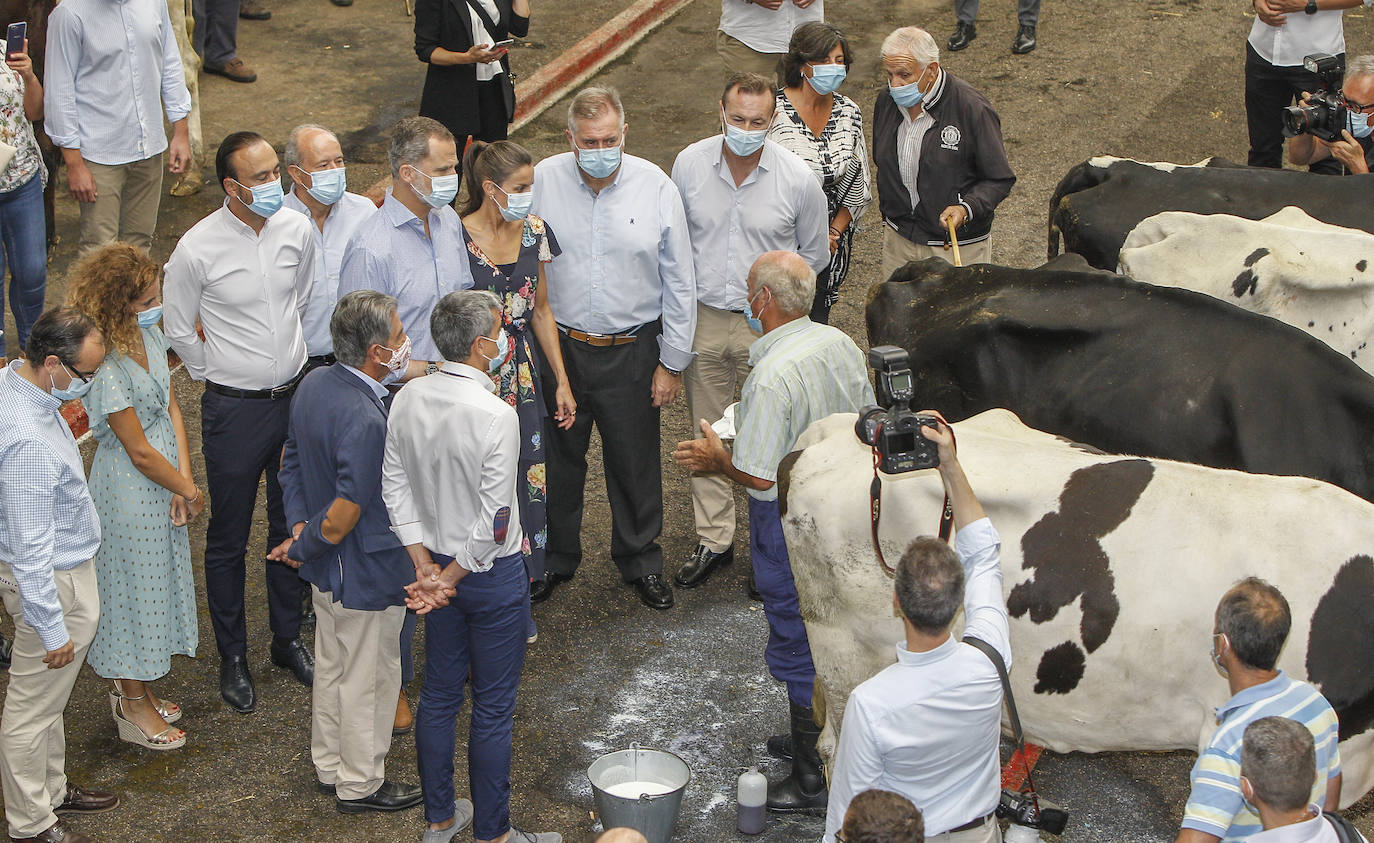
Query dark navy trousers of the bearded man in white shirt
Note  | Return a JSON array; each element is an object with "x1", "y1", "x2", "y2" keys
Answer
[{"x1": 201, "y1": 390, "x2": 301, "y2": 658}]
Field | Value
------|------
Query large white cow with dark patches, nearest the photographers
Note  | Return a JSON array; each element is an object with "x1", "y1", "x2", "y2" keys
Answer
[{"x1": 779, "y1": 411, "x2": 1374, "y2": 805}]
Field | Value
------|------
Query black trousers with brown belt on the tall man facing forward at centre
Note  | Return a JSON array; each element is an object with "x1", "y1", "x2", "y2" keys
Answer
[{"x1": 543, "y1": 321, "x2": 664, "y2": 582}]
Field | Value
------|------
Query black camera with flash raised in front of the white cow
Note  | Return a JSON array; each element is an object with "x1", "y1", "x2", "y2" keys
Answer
[{"x1": 855, "y1": 346, "x2": 940, "y2": 474}]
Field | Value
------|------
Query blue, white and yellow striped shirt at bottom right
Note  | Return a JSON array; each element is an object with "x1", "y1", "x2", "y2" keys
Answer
[{"x1": 1183, "y1": 670, "x2": 1341, "y2": 843}]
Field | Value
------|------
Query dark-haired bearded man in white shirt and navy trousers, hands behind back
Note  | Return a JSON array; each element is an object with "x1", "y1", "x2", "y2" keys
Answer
[{"x1": 162, "y1": 132, "x2": 315, "y2": 714}]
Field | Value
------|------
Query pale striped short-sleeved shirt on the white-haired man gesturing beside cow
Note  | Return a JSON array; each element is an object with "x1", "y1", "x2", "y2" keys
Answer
[{"x1": 731, "y1": 316, "x2": 874, "y2": 501}]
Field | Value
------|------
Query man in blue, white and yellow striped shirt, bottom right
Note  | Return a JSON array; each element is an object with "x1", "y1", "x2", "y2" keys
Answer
[{"x1": 1175, "y1": 577, "x2": 1341, "y2": 843}]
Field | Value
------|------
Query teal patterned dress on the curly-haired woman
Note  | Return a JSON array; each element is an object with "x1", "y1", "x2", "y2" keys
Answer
[{"x1": 82, "y1": 328, "x2": 198, "y2": 682}]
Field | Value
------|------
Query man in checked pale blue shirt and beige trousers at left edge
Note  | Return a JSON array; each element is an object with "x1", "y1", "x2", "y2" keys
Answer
[{"x1": 0, "y1": 308, "x2": 120, "y2": 840}]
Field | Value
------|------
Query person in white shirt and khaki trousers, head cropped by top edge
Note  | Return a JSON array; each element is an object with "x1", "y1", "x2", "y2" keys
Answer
[{"x1": 716, "y1": 0, "x2": 826, "y2": 78}]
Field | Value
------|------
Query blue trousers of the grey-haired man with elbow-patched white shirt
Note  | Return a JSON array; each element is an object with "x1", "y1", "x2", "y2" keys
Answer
[{"x1": 415, "y1": 553, "x2": 529, "y2": 840}]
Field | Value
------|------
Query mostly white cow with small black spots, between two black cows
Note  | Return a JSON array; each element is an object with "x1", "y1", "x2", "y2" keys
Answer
[{"x1": 1117, "y1": 207, "x2": 1374, "y2": 373}]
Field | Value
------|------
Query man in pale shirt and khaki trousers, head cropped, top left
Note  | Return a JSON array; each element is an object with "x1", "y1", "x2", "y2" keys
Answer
[{"x1": 43, "y1": 0, "x2": 191, "y2": 255}]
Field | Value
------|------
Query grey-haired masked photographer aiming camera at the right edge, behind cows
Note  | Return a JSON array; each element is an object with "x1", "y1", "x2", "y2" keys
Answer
[{"x1": 1283, "y1": 55, "x2": 1374, "y2": 173}]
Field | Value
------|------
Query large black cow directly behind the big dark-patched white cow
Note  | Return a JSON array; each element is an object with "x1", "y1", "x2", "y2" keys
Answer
[{"x1": 867, "y1": 258, "x2": 1374, "y2": 500}]
